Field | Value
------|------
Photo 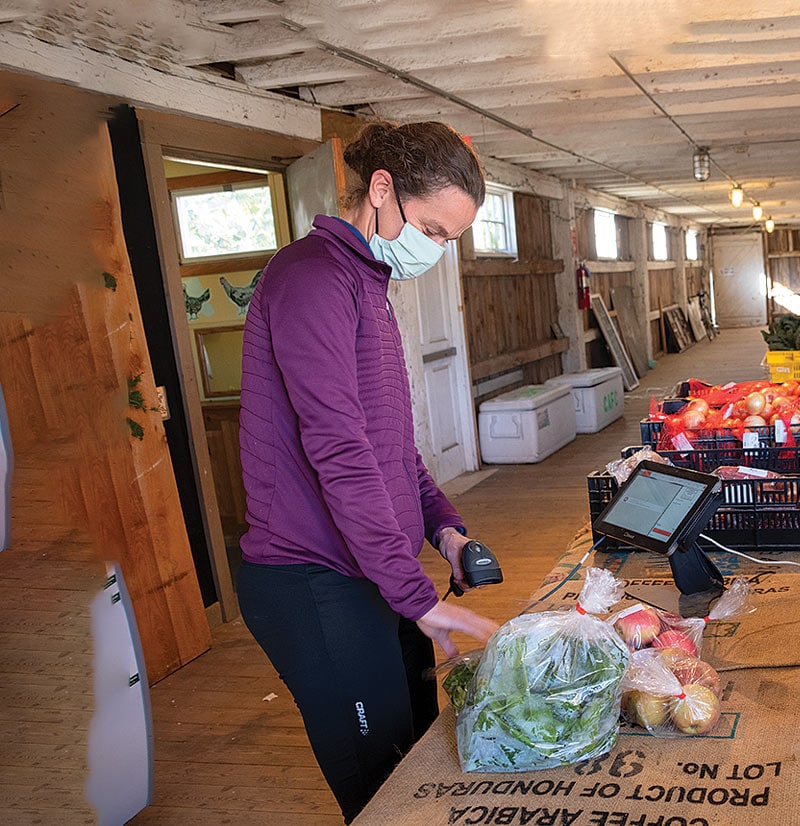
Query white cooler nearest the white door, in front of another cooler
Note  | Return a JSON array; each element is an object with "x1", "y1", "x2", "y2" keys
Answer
[{"x1": 478, "y1": 384, "x2": 577, "y2": 464}]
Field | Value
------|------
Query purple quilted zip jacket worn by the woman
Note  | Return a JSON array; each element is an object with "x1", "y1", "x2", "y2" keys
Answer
[{"x1": 240, "y1": 215, "x2": 463, "y2": 621}]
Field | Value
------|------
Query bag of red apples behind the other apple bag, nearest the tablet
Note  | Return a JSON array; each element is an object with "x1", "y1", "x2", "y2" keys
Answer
[{"x1": 608, "y1": 577, "x2": 755, "y2": 657}]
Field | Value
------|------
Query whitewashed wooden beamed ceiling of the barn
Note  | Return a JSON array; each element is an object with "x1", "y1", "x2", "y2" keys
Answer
[{"x1": 6, "y1": 0, "x2": 800, "y2": 226}]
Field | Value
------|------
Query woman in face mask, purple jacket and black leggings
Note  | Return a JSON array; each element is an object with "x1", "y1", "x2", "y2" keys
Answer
[{"x1": 238, "y1": 123, "x2": 497, "y2": 823}]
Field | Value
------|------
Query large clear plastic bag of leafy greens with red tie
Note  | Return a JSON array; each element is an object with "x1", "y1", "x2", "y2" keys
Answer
[{"x1": 456, "y1": 568, "x2": 629, "y2": 772}]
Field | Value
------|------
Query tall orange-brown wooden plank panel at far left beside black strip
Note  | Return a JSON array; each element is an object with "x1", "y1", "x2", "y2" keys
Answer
[{"x1": 0, "y1": 75, "x2": 210, "y2": 681}]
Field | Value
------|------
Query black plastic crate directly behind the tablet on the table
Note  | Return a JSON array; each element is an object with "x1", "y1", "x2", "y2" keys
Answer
[{"x1": 586, "y1": 470, "x2": 800, "y2": 551}]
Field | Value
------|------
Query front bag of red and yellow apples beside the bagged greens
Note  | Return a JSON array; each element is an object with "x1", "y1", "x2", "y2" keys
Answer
[{"x1": 621, "y1": 648, "x2": 721, "y2": 737}]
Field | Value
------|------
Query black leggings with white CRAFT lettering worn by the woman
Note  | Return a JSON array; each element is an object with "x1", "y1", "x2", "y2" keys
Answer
[{"x1": 237, "y1": 562, "x2": 438, "y2": 823}]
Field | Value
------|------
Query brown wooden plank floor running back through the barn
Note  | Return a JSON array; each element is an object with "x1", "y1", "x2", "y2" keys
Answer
[{"x1": 0, "y1": 329, "x2": 764, "y2": 826}]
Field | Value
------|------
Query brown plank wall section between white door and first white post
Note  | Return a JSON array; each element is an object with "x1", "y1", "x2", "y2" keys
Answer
[{"x1": 462, "y1": 193, "x2": 567, "y2": 402}]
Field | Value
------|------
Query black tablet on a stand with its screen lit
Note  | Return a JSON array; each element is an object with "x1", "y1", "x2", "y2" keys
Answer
[{"x1": 592, "y1": 460, "x2": 725, "y2": 617}]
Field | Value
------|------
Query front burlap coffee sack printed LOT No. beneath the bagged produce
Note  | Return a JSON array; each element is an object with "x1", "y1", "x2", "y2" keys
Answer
[{"x1": 355, "y1": 668, "x2": 800, "y2": 826}]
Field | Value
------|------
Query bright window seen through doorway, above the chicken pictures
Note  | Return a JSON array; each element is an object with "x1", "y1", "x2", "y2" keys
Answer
[{"x1": 172, "y1": 181, "x2": 278, "y2": 263}]
